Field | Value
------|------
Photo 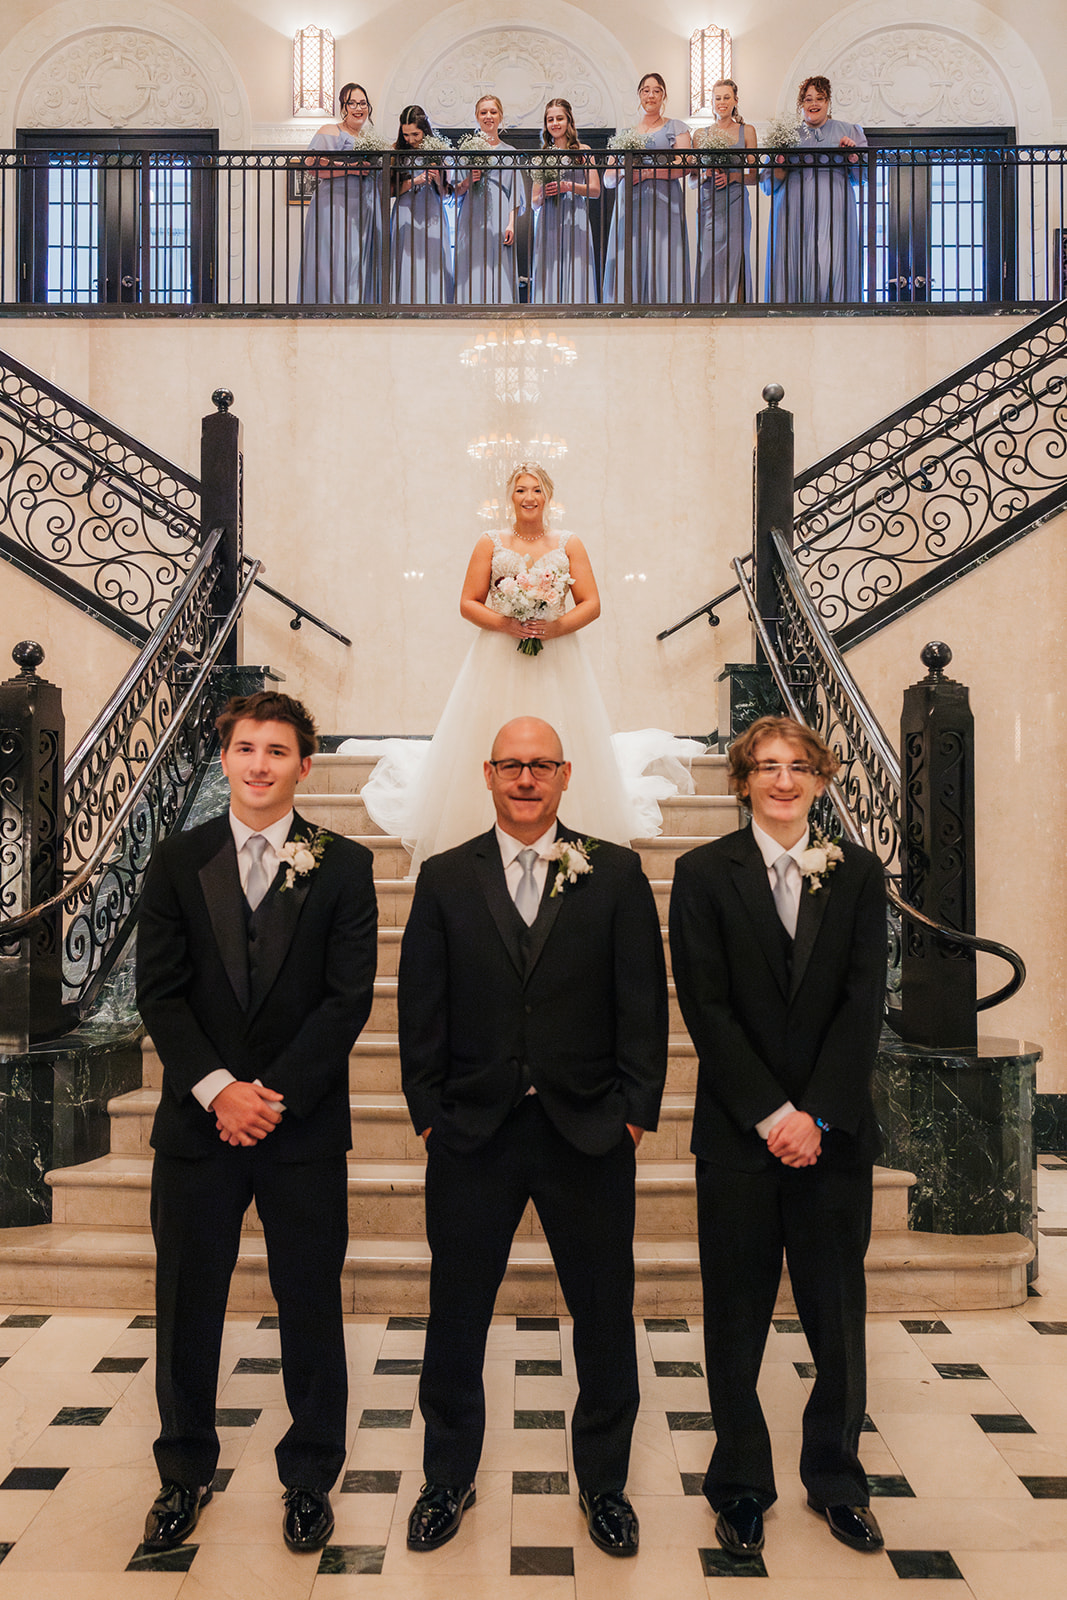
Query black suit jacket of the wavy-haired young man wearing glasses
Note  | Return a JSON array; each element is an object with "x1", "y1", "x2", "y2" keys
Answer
[{"x1": 670, "y1": 827, "x2": 886, "y2": 1171}]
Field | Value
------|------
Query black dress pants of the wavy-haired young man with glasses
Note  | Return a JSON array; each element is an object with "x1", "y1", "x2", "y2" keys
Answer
[{"x1": 696, "y1": 1160, "x2": 872, "y2": 1510}]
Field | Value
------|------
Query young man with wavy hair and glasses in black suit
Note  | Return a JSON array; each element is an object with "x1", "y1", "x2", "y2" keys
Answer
[{"x1": 670, "y1": 717, "x2": 886, "y2": 1557}]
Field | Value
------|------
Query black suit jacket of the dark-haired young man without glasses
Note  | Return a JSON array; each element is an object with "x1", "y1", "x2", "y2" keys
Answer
[{"x1": 138, "y1": 814, "x2": 378, "y2": 1162}]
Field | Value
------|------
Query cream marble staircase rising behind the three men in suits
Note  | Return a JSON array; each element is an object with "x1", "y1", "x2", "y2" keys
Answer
[{"x1": 0, "y1": 755, "x2": 1030, "y2": 1315}]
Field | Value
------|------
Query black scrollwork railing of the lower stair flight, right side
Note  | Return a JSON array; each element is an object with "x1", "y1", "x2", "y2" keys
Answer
[{"x1": 733, "y1": 533, "x2": 1025, "y2": 1011}]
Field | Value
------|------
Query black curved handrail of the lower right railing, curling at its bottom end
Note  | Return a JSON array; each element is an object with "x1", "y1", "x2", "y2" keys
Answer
[{"x1": 733, "y1": 544, "x2": 1025, "y2": 1011}]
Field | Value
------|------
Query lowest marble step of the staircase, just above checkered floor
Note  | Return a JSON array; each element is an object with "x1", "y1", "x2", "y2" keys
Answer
[{"x1": 0, "y1": 1222, "x2": 1033, "y2": 1317}]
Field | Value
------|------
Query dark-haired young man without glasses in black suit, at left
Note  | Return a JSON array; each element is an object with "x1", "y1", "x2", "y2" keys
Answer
[{"x1": 138, "y1": 693, "x2": 378, "y2": 1550}]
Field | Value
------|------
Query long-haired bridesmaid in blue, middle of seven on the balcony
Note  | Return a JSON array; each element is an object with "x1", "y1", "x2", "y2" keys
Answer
[{"x1": 531, "y1": 99, "x2": 600, "y2": 306}]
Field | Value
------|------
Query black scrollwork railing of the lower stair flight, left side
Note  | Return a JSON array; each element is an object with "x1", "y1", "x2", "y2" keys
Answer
[{"x1": 0, "y1": 530, "x2": 259, "y2": 1013}]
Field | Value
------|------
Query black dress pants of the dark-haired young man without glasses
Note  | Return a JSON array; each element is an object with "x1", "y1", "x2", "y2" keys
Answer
[{"x1": 152, "y1": 1144, "x2": 349, "y2": 1491}]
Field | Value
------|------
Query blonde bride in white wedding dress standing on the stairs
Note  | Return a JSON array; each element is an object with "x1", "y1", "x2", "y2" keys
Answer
[{"x1": 355, "y1": 462, "x2": 704, "y2": 877}]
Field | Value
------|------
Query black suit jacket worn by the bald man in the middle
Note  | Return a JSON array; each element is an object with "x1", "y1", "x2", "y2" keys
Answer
[{"x1": 400, "y1": 827, "x2": 667, "y2": 1154}]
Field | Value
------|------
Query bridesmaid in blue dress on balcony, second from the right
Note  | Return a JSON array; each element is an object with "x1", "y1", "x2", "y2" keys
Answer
[{"x1": 696, "y1": 78, "x2": 755, "y2": 304}]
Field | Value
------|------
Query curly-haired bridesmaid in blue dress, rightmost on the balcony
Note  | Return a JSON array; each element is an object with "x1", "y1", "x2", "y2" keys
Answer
[{"x1": 766, "y1": 77, "x2": 867, "y2": 306}]
